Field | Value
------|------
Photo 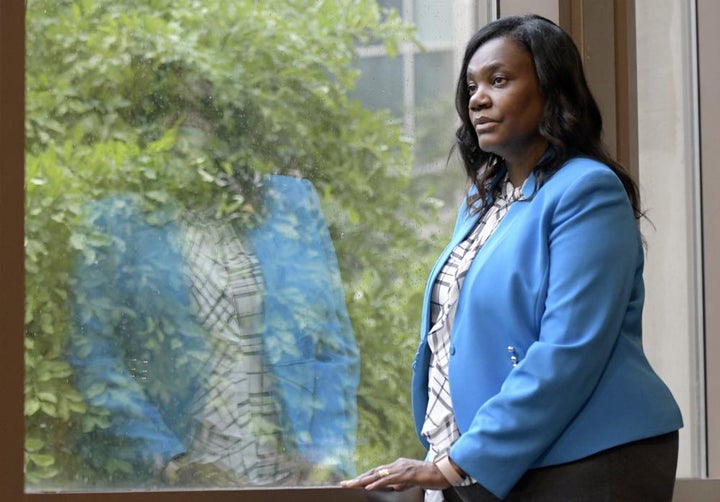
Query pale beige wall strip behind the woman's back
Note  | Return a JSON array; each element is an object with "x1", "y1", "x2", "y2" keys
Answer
[{"x1": 635, "y1": 0, "x2": 704, "y2": 477}]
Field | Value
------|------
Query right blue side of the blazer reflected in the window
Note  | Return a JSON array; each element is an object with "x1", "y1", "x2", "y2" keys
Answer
[{"x1": 251, "y1": 176, "x2": 359, "y2": 476}]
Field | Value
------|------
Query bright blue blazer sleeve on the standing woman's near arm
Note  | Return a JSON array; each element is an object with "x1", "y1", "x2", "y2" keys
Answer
[{"x1": 450, "y1": 169, "x2": 642, "y2": 497}]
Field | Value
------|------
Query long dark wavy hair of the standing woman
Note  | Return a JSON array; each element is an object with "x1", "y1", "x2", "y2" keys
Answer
[{"x1": 454, "y1": 15, "x2": 642, "y2": 219}]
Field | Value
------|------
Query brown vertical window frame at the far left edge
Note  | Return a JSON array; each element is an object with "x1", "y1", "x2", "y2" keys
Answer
[{"x1": 0, "y1": 1, "x2": 25, "y2": 500}]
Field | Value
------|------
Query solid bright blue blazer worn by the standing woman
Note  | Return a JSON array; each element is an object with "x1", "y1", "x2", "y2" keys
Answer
[{"x1": 412, "y1": 158, "x2": 682, "y2": 498}]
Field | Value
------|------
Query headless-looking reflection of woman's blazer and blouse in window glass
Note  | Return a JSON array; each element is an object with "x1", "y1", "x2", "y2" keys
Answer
[{"x1": 73, "y1": 176, "x2": 358, "y2": 486}]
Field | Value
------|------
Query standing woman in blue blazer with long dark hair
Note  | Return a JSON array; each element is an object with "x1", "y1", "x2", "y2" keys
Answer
[{"x1": 343, "y1": 16, "x2": 682, "y2": 501}]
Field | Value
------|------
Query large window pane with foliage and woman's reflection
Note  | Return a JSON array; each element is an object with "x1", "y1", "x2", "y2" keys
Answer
[{"x1": 25, "y1": 0, "x2": 458, "y2": 491}]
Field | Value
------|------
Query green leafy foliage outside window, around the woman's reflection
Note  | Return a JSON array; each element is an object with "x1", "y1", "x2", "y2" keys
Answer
[{"x1": 25, "y1": 0, "x2": 442, "y2": 485}]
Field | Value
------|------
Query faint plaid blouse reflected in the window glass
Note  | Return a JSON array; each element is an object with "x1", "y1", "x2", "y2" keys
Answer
[{"x1": 182, "y1": 215, "x2": 294, "y2": 485}]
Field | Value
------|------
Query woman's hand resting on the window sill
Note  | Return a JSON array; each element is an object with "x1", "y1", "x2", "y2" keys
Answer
[{"x1": 340, "y1": 458, "x2": 450, "y2": 491}]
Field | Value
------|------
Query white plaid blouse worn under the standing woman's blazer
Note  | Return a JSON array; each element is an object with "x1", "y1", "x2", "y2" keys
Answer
[{"x1": 421, "y1": 177, "x2": 522, "y2": 502}]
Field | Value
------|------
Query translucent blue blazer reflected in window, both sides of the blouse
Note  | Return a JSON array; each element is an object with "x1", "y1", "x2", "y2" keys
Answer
[{"x1": 71, "y1": 176, "x2": 359, "y2": 479}]
